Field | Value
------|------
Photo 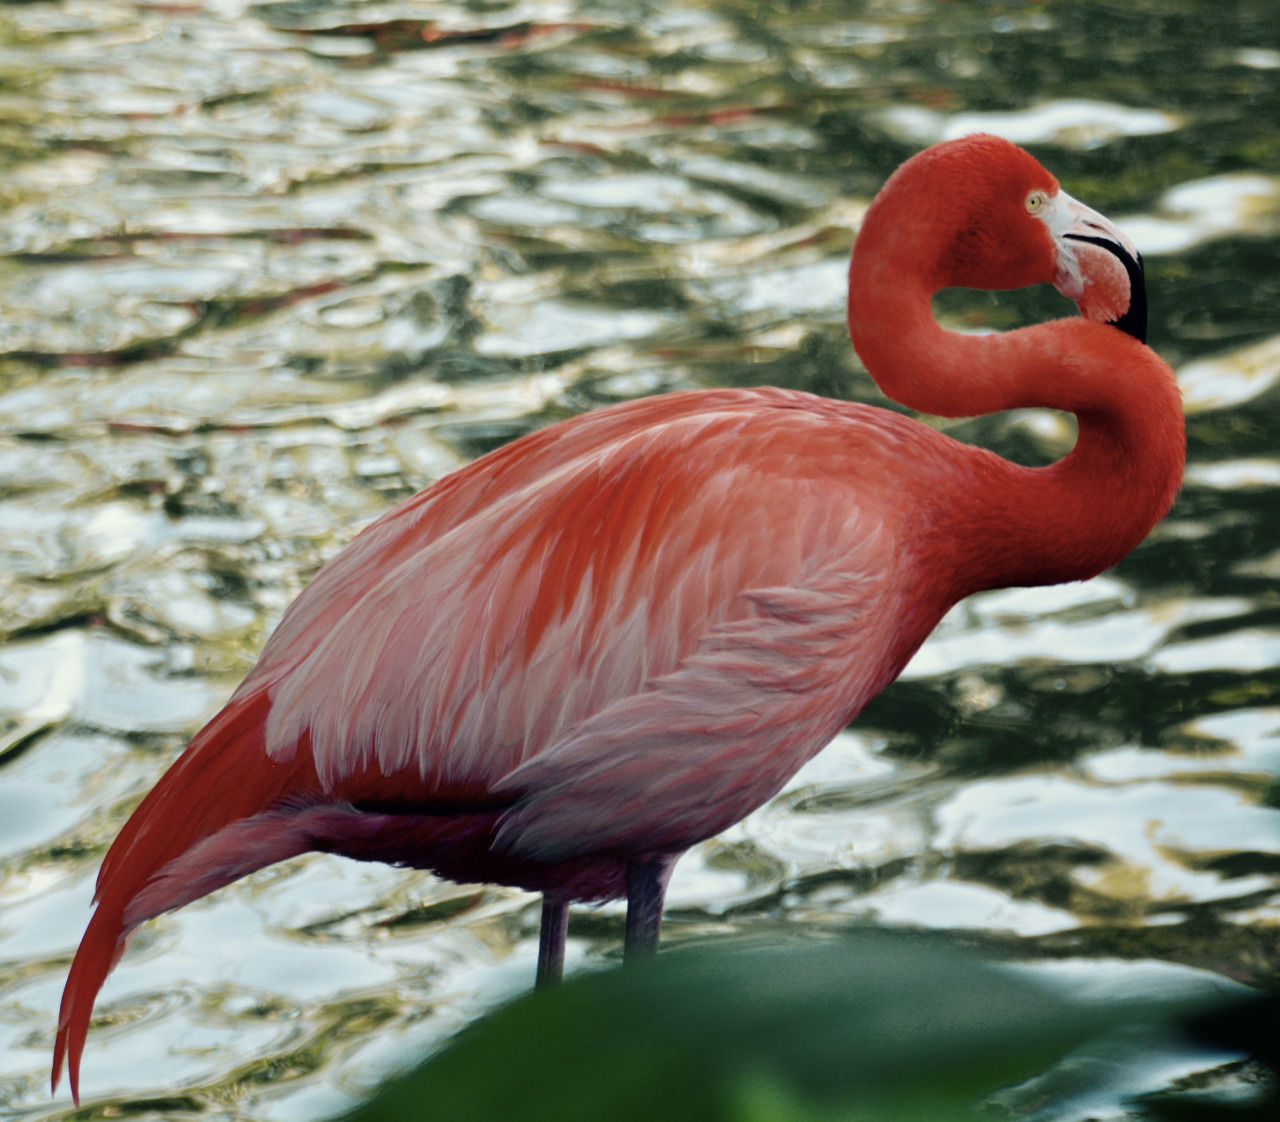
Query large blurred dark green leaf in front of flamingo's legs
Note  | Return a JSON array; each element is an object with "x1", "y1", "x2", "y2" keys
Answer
[{"x1": 349, "y1": 933, "x2": 1258, "y2": 1122}]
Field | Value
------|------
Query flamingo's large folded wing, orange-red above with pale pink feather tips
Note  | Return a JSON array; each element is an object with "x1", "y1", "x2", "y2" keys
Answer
[{"x1": 254, "y1": 391, "x2": 942, "y2": 789}]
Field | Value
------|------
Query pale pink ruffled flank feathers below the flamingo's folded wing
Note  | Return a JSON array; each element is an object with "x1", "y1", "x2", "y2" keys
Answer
[{"x1": 483, "y1": 550, "x2": 902, "y2": 861}]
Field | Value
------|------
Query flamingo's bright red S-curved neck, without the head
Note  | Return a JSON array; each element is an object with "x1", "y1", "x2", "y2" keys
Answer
[{"x1": 849, "y1": 263, "x2": 1185, "y2": 599}]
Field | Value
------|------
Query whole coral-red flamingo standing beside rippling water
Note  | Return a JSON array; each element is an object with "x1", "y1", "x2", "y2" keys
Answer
[{"x1": 51, "y1": 133, "x2": 1185, "y2": 1103}]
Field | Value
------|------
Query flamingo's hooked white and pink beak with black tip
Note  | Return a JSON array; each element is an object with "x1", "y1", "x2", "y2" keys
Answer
[{"x1": 1044, "y1": 191, "x2": 1147, "y2": 343}]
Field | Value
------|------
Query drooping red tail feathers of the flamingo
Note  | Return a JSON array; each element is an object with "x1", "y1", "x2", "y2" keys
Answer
[{"x1": 52, "y1": 690, "x2": 319, "y2": 1104}]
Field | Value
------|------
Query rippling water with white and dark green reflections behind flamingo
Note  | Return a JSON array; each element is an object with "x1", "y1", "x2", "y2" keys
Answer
[{"x1": 0, "y1": 0, "x2": 1280, "y2": 1119}]
